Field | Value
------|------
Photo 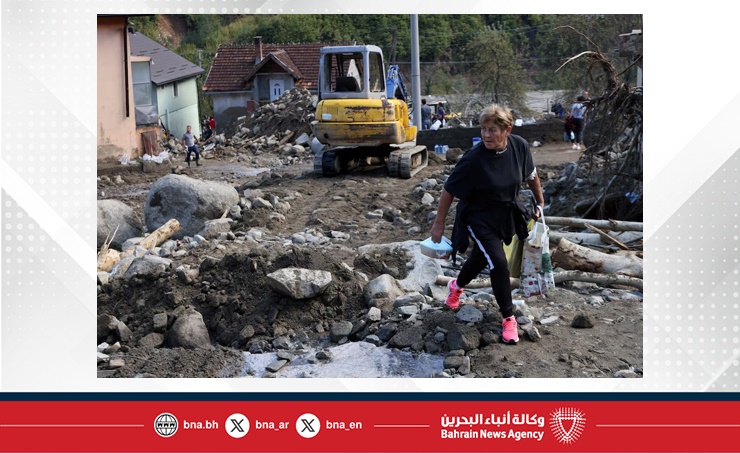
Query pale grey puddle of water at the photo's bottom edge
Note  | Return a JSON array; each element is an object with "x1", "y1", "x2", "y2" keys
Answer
[{"x1": 244, "y1": 342, "x2": 444, "y2": 378}]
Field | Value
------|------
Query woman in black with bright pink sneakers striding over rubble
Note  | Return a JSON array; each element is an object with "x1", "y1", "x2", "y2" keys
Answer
[{"x1": 431, "y1": 104, "x2": 545, "y2": 344}]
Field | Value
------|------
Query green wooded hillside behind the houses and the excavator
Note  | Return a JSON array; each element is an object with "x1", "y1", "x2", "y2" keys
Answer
[{"x1": 130, "y1": 14, "x2": 642, "y2": 106}]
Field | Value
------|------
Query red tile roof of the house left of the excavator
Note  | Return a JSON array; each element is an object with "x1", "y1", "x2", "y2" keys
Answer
[{"x1": 203, "y1": 43, "x2": 330, "y2": 93}]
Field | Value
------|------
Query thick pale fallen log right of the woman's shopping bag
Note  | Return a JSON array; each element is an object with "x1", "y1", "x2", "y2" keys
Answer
[{"x1": 550, "y1": 238, "x2": 642, "y2": 278}]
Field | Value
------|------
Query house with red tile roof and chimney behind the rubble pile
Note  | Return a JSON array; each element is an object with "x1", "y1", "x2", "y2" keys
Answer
[{"x1": 203, "y1": 36, "x2": 330, "y2": 133}]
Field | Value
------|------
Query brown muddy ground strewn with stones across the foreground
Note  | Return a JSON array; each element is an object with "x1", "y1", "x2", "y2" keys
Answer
[{"x1": 98, "y1": 143, "x2": 643, "y2": 378}]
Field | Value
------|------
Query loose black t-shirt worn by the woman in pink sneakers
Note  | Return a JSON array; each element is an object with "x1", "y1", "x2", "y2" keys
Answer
[{"x1": 445, "y1": 135, "x2": 535, "y2": 245}]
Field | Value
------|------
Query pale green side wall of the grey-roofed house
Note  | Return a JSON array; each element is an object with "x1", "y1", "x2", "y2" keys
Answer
[{"x1": 156, "y1": 77, "x2": 202, "y2": 139}]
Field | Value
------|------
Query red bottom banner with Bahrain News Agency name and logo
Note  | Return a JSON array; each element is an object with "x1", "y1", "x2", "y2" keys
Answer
[{"x1": 0, "y1": 395, "x2": 740, "y2": 452}]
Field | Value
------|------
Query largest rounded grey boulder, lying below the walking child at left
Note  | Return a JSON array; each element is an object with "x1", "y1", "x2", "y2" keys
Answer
[{"x1": 144, "y1": 175, "x2": 239, "y2": 239}]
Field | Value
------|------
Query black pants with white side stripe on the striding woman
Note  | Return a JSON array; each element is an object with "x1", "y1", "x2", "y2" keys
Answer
[{"x1": 457, "y1": 225, "x2": 514, "y2": 318}]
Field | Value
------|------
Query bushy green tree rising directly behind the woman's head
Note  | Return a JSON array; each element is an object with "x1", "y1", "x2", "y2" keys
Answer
[{"x1": 466, "y1": 30, "x2": 528, "y2": 111}]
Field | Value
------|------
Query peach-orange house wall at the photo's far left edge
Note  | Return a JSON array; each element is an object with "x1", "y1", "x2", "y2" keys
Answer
[{"x1": 97, "y1": 17, "x2": 138, "y2": 159}]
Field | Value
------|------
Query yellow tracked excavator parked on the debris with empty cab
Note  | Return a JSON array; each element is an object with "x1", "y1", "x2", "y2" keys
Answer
[{"x1": 313, "y1": 45, "x2": 428, "y2": 178}]
